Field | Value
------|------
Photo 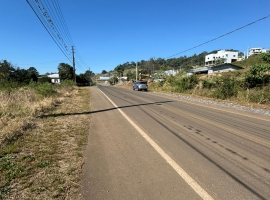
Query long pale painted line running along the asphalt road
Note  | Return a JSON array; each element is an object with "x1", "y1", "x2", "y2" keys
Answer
[{"x1": 100, "y1": 90, "x2": 213, "y2": 200}]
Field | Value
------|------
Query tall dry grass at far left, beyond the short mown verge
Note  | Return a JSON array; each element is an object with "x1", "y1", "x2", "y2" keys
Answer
[{"x1": 0, "y1": 82, "x2": 74, "y2": 146}]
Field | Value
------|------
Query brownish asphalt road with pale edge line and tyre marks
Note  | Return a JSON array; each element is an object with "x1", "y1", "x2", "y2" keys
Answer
[{"x1": 82, "y1": 85, "x2": 270, "y2": 200}]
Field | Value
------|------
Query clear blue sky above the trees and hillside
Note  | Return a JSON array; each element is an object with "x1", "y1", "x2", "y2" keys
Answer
[{"x1": 0, "y1": 0, "x2": 270, "y2": 74}]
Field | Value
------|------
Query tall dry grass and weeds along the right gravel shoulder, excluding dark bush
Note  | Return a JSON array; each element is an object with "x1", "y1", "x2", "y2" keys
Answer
[{"x1": 150, "y1": 71, "x2": 270, "y2": 104}]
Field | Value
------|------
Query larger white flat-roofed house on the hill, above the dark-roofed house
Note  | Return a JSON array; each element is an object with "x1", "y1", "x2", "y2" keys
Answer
[{"x1": 205, "y1": 50, "x2": 238, "y2": 66}]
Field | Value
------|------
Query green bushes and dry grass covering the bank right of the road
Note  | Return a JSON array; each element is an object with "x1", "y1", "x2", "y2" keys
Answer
[{"x1": 150, "y1": 53, "x2": 270, "y2": 105}]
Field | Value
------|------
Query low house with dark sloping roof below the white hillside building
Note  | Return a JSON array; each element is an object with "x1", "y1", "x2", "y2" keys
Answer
[{"x1": 186, "y1": 63, "x2": 243, "y2": 76}]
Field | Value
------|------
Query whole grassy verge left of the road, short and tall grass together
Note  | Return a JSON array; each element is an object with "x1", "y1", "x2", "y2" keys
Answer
[{"x1": 0, "y1": 81, "x2": 90, "y2": 199}]
